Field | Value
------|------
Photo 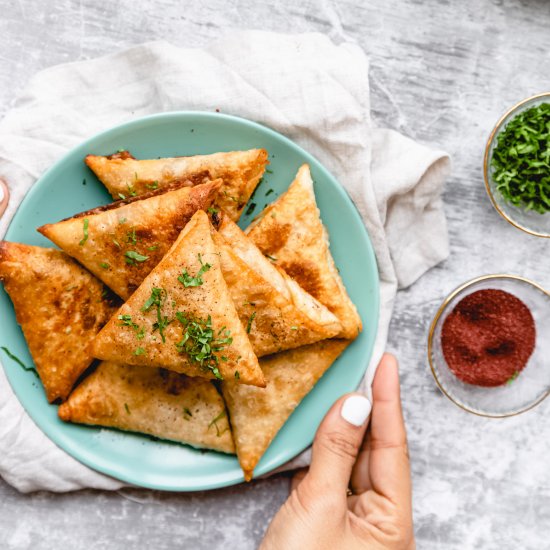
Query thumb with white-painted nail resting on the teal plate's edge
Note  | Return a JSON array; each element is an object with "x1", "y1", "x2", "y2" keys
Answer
[{"x1": 304, "y1": 393, "x2": 371, "y2": 497}]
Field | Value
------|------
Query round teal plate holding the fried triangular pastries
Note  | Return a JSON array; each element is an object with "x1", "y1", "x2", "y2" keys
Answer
[{"x1": 0, "y1": 112, "x2": 379, "y2": 491}]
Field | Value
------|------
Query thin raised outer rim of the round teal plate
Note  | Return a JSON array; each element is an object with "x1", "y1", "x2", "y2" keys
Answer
[{"x1": 0, "y1": 110, "x2": 380, "y2": 492}]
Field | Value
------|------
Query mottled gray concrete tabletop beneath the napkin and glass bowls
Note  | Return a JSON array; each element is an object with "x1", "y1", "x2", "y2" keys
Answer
[{"x1": 0, "y1": 0, "x2": 550, "y2": 550}]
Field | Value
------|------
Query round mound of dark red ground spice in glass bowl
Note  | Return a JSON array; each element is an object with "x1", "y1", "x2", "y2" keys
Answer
[{"x1": 441, "y1": 289, "x2": 536, "y2": 386}]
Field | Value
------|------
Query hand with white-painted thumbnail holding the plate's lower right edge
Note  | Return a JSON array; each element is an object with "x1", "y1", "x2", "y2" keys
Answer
[{"x1": 260, "y1": 354, "x2": 415, "y2": 550}]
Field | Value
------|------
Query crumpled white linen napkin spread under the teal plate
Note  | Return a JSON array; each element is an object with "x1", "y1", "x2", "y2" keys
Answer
[{"x1": 0, "y1": 31, "x2": 449, "y2": 492}]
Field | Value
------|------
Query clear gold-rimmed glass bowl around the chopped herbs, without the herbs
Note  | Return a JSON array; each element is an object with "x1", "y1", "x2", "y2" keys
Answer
[{"x1": 483, "y1": 92, "x2": 550, "y2": 238}]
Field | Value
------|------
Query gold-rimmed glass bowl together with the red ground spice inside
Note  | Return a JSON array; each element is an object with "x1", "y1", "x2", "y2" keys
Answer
[{"x1": 428, "y1": 274, "x2": 550, "y2": 418}]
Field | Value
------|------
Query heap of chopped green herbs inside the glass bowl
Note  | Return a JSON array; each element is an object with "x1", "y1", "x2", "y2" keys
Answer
[{"x1": 491, "y1": 103, "x2": 550, "y2": 214}]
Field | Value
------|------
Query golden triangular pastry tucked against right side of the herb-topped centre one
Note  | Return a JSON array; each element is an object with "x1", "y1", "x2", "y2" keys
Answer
[{"x1": 214, "y1": 215, "x2": 342, "y2": 357}]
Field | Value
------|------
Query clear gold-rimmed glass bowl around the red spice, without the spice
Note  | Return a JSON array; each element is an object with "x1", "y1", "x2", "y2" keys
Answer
[{"x1": 428, "y1": 274, "x2": 550, "y2": 418}]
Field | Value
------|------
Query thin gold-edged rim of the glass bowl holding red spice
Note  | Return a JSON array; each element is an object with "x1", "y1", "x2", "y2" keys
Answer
[{"x1": 428, "y1": 273, "x2": 550, "y2": 418}]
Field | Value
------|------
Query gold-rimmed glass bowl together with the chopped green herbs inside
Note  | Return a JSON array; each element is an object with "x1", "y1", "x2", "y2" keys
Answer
[{"x1": 484, "y1": 92, "x2": 550, "y2": 237}]
